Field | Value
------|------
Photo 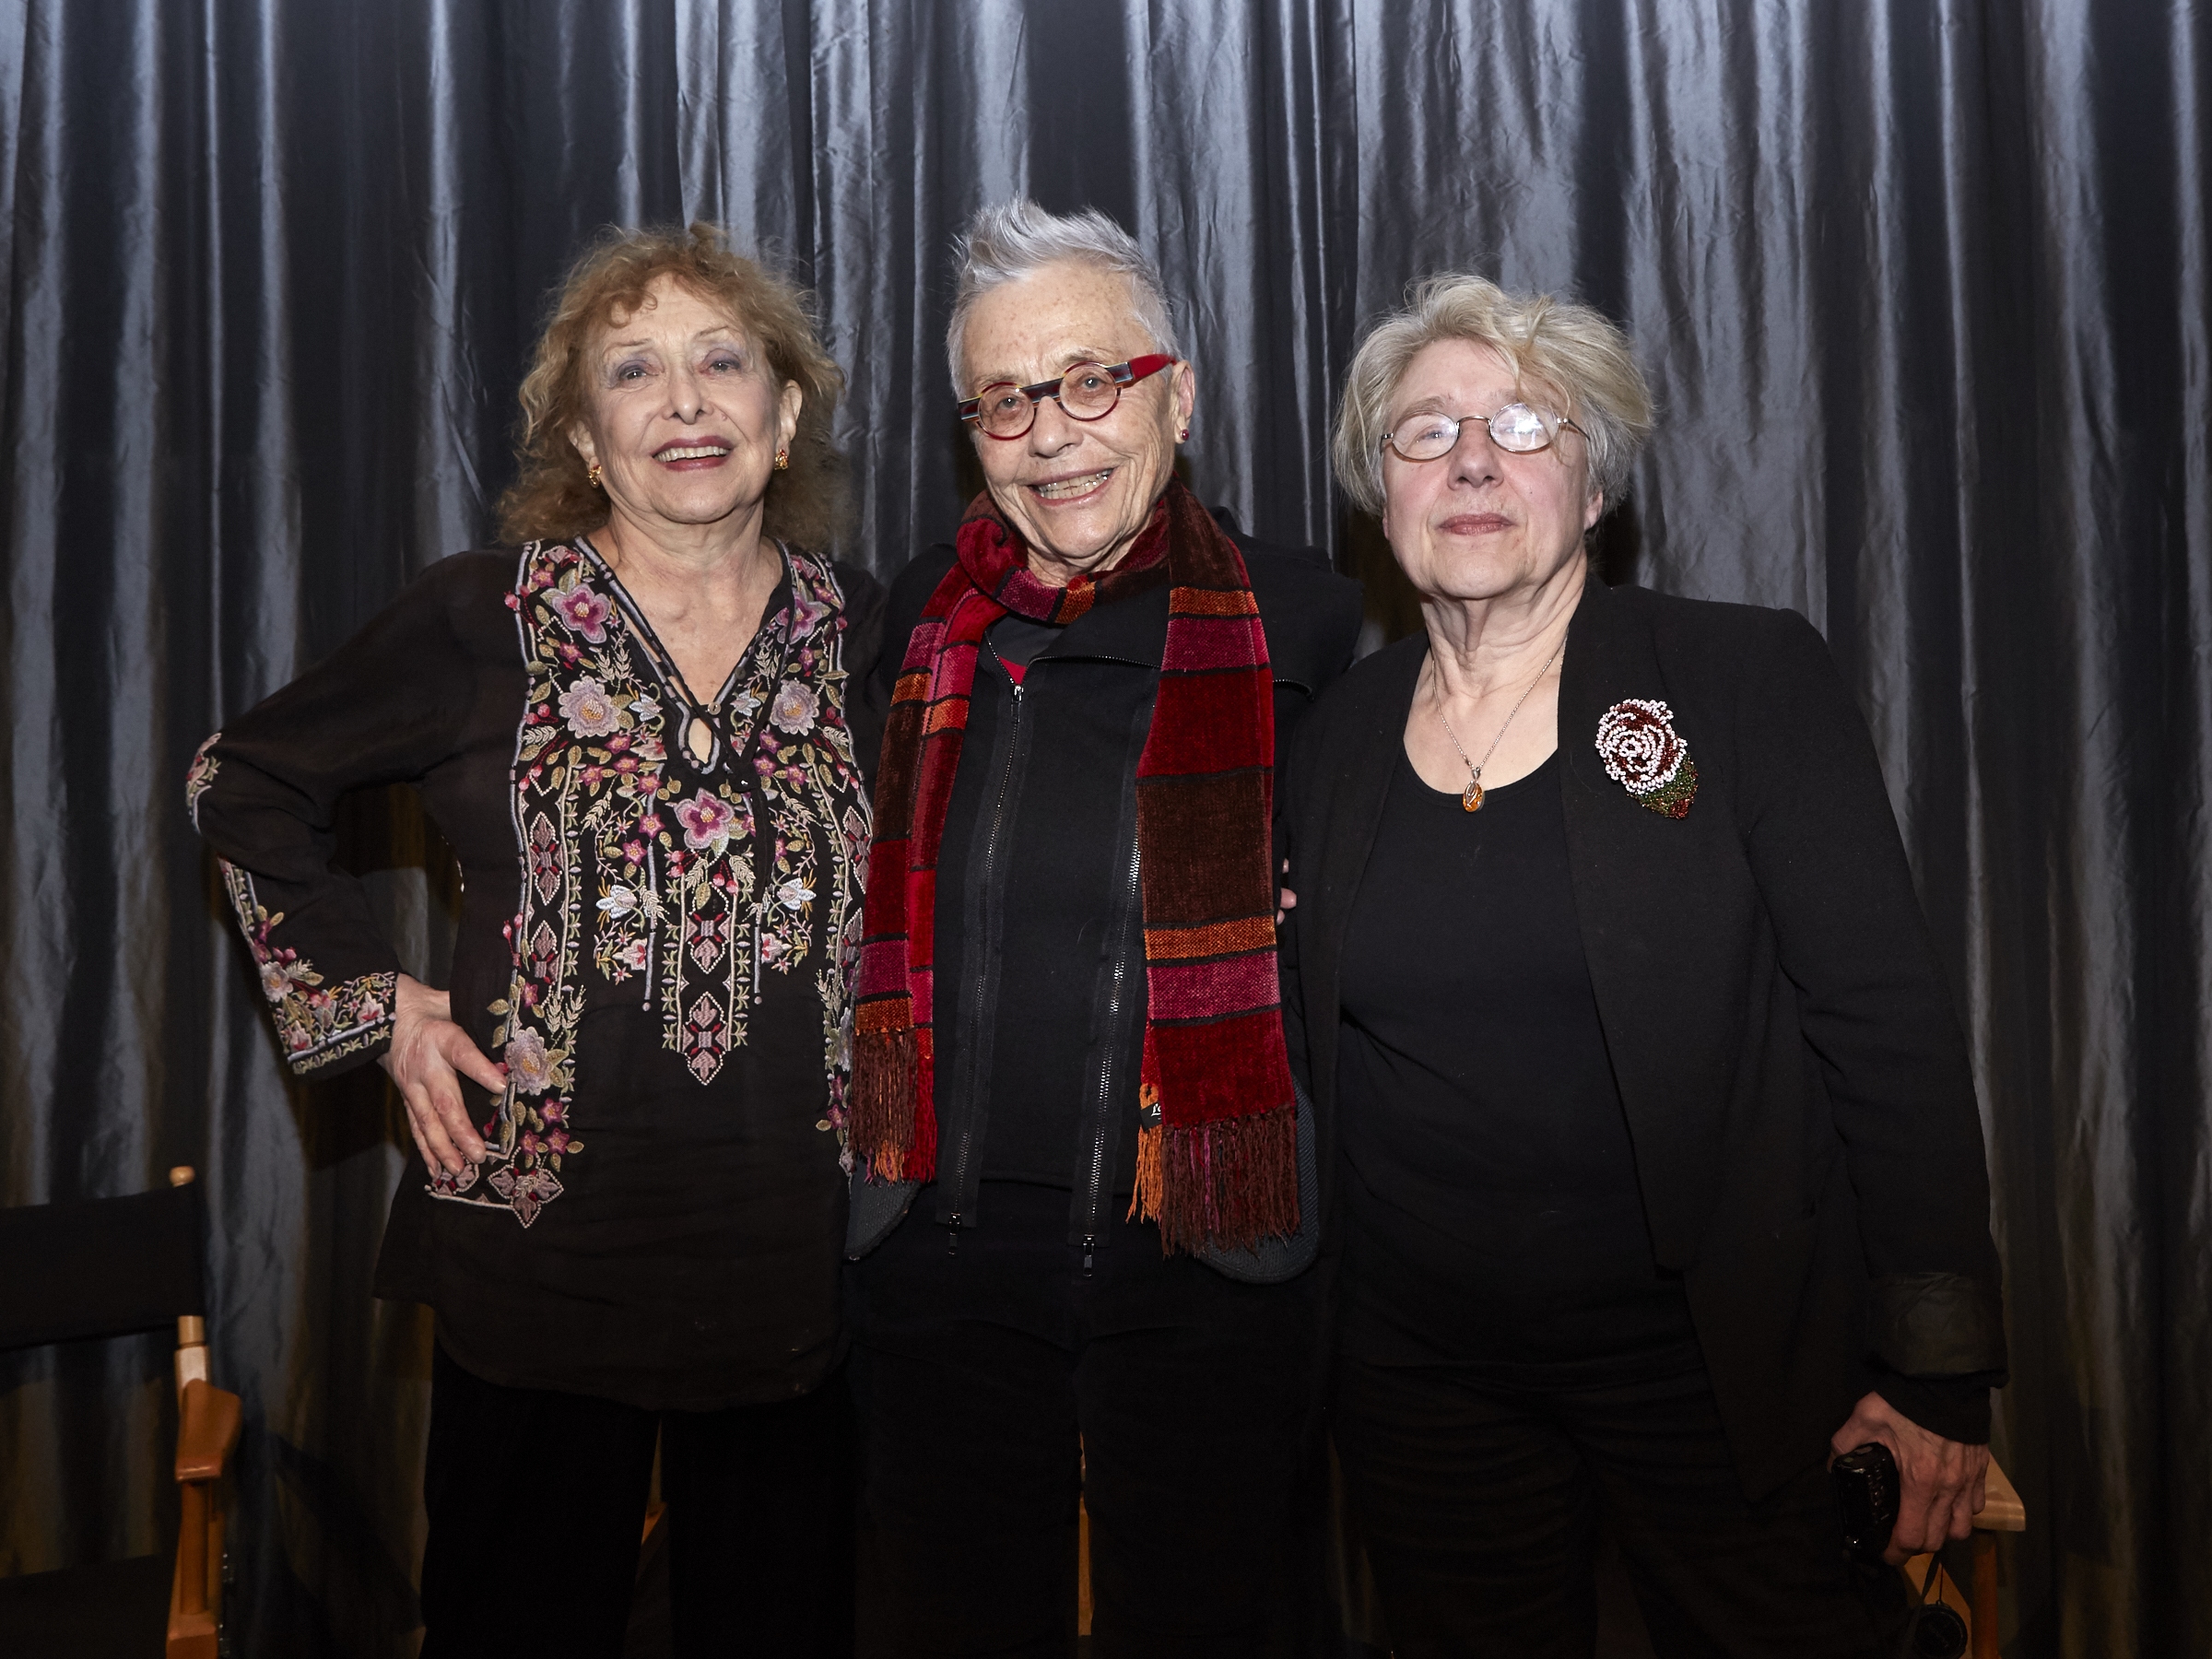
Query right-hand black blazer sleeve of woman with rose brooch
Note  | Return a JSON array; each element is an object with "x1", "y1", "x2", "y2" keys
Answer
[{"x1": 1738, "y1": 613, "x2": 2006, "y2": 1440}]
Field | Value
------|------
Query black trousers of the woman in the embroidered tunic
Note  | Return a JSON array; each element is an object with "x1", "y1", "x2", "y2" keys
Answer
[{"x1": 422, "y1": 1347, "x2": 852, "y2": 1659}]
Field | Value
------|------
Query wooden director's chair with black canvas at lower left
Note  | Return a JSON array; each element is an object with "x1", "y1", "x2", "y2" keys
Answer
[{"x1": 0, "y1": 1166, "x2": 239, "y2": 1659}]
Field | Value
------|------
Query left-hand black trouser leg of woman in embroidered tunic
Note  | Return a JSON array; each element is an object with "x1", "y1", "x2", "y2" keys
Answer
[{"x1": 422, "y1": 1347, "x2": 659, "y2": 1659}]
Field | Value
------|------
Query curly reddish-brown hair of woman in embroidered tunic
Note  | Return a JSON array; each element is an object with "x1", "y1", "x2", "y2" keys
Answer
[{"x1": 500, "y1": 221, "x2": 852, "y2": 553}]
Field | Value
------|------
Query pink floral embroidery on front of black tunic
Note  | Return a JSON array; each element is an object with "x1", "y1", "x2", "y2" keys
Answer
[{"x1": 429, "y1": 542, "x2": 869, "y2": 1226}]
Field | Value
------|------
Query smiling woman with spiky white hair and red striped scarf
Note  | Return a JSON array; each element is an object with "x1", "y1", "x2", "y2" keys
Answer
[{"x1": 847, "y1": 201, "x2": 1360, "y2": 1659}]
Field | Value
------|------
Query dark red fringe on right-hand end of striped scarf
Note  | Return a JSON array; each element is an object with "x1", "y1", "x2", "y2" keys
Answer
[{"x1": 1128, "y1": 1104, "x2": 1299, "y2": 1256}]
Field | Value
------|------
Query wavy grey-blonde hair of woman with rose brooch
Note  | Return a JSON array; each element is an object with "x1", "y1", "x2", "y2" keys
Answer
[{"x1": 1334, "y1": 272, "x2": 1653, "y2": 513}]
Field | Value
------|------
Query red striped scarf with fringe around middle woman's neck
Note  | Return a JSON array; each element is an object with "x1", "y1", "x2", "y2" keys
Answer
[{"x1": 852, "y1": 482, "x2": 1299, "y2": 1250}]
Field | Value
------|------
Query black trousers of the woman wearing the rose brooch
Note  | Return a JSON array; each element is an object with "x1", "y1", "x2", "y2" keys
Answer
[{"x1": 1332, "y1": 1359, "x2": 1904, "y2": 1659}]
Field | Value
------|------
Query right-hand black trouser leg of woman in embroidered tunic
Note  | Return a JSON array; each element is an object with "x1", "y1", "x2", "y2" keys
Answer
[{"x1": 662, "y1": 1376, "x2": 852, "y2": 1659}]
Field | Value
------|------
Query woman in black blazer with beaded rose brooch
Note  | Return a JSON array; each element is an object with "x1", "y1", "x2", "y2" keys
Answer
[{"x1": 1288, "y1": 276, "x2": 2004, "y2": 1659}]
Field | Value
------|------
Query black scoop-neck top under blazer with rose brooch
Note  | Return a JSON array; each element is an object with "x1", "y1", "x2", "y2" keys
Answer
[{"x1": 1338, "y1": 754, "x2": 1699, "y2": 1387}]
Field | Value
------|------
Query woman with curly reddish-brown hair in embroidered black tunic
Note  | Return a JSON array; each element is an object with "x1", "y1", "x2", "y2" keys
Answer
[{"x1": 188, "y1": 226, "x2": 883, "y2": 1659}]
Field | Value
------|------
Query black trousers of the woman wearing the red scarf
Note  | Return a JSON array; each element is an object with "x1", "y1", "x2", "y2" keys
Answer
[{"x1": 847, "y1": 1182, "x2": 1325, "y2": 1659}]
